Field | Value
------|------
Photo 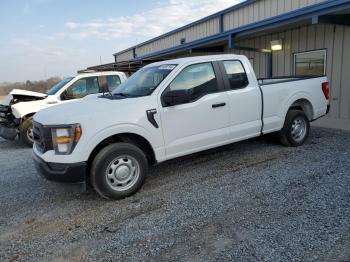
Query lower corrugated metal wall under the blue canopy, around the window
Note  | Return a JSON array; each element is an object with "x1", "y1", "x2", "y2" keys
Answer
[{"x1": 226, "y1": 24, "x2": 350, "y2": 119}]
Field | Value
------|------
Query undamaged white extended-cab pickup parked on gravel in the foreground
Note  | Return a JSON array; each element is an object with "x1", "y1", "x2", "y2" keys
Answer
[{"x1": 33, "y1": 55, "x2": 329, "y2": 199}]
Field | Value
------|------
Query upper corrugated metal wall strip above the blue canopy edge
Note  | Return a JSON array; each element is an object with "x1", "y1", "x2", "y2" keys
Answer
[{"x1": 117, "y1": 0, "x2": 326, "y2": 61}]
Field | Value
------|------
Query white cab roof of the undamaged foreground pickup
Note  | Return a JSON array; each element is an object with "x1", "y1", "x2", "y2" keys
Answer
[{"x1": 146, "y1": 54, "x2": 244, "y2": 67}]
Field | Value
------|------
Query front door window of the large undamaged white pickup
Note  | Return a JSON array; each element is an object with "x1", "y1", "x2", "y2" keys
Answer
[{"x1": 169, "y1": 63, "x2": 219, "y2": 102}]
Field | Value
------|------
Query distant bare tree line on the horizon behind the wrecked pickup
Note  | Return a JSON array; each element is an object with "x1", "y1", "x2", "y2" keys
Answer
[{"x1": 0, "y1": 77, "x2": 61, "y2": 96}]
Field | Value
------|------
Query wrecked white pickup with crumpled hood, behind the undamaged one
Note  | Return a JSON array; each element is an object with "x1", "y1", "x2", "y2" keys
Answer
[{"x1": 0, "y1": 72, "x2": 126, "y2": 147}]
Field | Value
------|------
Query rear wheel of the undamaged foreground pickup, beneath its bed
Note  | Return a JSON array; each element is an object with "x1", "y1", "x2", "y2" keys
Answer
[{"x1": 280, "y1": 110, "x2": 310, "y2": 147}]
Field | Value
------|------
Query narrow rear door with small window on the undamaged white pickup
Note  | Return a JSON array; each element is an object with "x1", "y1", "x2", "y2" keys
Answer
[{"x1": 219, "y1": 59, "x2": 262, "y2": 141}]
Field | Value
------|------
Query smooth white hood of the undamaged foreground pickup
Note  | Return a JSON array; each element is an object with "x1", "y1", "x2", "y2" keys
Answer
[{"x1": 34, "y1": 95, "x2": 154, "y2": 125}]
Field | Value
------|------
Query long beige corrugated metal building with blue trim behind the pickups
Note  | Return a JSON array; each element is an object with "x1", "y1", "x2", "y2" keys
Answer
[{"x1": 85, "y1": 0, "x2": 350, "y2": 129}]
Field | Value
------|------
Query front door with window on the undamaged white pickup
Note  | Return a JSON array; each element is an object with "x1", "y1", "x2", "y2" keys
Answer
[{"x1": 161, "y1": 62, "x2": 230, "y2": 158}]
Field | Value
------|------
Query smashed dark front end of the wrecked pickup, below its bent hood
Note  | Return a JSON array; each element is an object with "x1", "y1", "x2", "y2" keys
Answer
[{"x1": 0, "y1": 105, "x2": 20, "y2": 140}]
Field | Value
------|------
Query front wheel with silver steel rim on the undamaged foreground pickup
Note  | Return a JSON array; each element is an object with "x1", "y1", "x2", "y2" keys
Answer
[{"x1": 90, "y1": 143, "x2": 148, "y2": 199}]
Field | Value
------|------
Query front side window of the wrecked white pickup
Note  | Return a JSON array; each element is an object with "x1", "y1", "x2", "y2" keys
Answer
[{"x1": 62, "y1": 76, "x2": 100, "y2": 100}]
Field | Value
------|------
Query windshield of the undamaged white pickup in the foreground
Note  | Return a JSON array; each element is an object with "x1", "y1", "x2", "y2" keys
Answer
[{"x1": 112, "y1": 65, "x2": 176, "y2": 97}]
